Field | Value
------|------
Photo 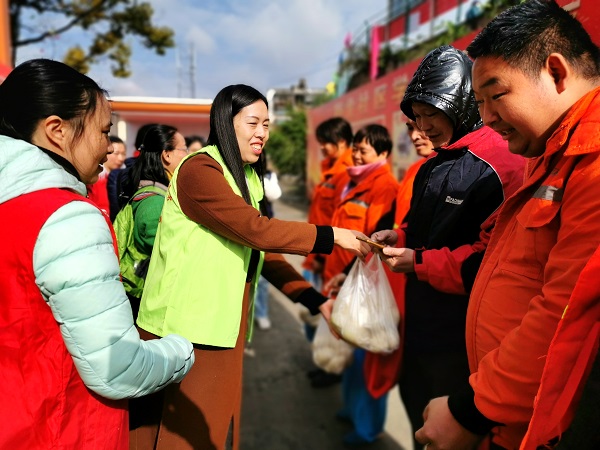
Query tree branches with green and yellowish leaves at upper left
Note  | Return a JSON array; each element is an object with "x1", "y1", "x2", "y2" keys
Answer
[{"x1": 9, "y1": 0, "x2": 175, "y2": 78}]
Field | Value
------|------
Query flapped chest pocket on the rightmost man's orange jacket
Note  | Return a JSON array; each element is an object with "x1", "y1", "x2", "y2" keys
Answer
[{"x1": 499, "y1": 198, "x2": 561, "y2": 281}]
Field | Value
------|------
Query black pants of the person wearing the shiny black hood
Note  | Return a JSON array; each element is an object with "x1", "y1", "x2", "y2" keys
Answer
[{"x1": 399, "y1": 350, "x2": 470, "y2": 449}]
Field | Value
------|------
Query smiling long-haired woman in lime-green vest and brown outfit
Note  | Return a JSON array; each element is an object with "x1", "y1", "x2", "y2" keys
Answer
[{"x1": 132, "y1": 84, "x2": 369, "y2": 450}]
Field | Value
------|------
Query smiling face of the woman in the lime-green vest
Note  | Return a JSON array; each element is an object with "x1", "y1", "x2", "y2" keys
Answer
[{"x1": 233, "y1": 100, "x2": 269, "y2": 164}]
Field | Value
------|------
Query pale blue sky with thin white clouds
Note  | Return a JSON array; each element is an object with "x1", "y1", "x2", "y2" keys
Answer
[{"x1": 17, "y1": 0, "x2": 387, "y2": 99}]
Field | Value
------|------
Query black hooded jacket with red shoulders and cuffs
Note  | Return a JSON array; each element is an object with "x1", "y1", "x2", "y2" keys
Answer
[{"x1": 401, "y1": 45, "x2": 524, "y2": 353}]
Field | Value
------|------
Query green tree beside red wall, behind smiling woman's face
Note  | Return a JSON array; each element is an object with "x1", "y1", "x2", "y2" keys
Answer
[{"x1": 267, "y1": 108, "x2": 306, "y2": 180}]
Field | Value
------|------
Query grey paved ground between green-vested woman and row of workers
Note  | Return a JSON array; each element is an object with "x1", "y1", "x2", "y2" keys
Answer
[{"x1": 241, "y1": 190, "x2": 412, "y2": 450}]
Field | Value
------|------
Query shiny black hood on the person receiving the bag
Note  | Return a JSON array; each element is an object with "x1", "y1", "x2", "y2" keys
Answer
[{"x1": 400, "y1": 45, "x2": 482, "y2": 142}]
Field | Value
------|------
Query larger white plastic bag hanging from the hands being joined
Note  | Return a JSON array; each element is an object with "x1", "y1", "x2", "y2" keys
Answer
[{"x1": 331, "y1": 255, "x2": 400, "y2": 353}]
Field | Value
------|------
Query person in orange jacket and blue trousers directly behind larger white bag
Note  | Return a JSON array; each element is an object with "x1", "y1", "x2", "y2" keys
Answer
[{"x1": 323, "y1": 124, "x2": 399, "y2": 445}]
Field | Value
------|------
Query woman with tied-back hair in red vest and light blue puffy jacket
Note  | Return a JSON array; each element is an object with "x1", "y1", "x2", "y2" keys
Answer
[{"x1": 0, "y1": 59, "x2": 194, "y2": 450}]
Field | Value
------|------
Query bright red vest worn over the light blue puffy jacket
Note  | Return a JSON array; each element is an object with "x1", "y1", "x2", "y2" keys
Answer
[{"x1": 0, "y1": 189, "x2": 129, "y2": 450}]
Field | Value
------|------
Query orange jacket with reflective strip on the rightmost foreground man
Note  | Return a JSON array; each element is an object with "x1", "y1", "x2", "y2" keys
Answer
[{"x1": 466, "y1": 88, "x2": 600, "y2": 449}]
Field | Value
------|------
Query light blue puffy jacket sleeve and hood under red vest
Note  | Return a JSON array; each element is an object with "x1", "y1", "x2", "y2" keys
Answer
[{"x1": 0, "y1": 136, "x2": 194, "y2": 399}]
